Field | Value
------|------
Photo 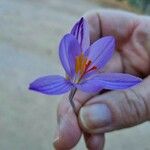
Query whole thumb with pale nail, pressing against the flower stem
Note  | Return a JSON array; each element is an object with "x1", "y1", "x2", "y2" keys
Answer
[{"x1": 79, "y1": 76, "x2": 150, "y2": 133}]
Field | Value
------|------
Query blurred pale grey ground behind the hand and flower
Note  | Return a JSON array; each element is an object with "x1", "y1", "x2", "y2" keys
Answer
[{"x1": 0, "y1": 0, "x2": 150, "y2": 150}]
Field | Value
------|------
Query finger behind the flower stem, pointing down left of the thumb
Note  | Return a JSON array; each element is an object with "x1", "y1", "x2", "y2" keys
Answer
[{"x1": 54, "y1": 91, "x2": 93, "y2": 150}]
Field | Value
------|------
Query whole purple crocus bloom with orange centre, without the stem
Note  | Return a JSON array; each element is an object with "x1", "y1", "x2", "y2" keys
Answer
[{"x1": 29, "y1": 18, "x2": 141, "y2": 95}]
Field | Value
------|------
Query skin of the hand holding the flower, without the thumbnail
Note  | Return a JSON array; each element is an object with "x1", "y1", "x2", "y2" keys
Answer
[{"x1": 54, "y1": 9, "x2": 150, "y2": 150}]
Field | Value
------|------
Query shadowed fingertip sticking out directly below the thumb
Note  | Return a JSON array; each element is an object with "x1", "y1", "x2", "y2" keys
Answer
[{"x1": 84, "y1": 133, "x2": 105, "y2": 150}]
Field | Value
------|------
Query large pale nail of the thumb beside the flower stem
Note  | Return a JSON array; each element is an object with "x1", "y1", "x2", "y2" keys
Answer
[{"x1": 80, "y1": 104, "x2": 112, "y2": 130}]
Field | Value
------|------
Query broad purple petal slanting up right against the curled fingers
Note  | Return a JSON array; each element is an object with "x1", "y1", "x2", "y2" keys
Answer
[{"x1": 85, "y1": 36, "x2": 115, "y2": 69}]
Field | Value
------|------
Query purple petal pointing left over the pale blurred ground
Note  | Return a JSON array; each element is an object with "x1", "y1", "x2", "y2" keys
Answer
[{"x1": 29, "y1": 75, "x2": 72, "y2": 95}]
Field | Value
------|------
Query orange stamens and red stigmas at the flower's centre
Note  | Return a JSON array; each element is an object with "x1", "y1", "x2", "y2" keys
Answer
[{"x1": 75, "y1": 54, "x2": 97, "y2": 80}]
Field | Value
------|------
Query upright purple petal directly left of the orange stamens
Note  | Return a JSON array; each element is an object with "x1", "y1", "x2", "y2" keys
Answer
[{"x1": 59, "y1": 34, "x2": 81, "y2": 77}]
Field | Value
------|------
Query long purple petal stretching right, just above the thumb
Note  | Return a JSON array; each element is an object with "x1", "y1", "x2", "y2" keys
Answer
[{"x1": 75, "y1": 73, "x2": 142, "y2": 92}]
